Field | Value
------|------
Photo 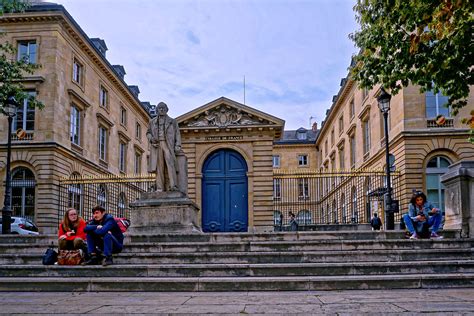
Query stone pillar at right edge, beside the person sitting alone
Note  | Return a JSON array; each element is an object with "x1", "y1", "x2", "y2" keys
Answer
[{"x1": 441, "y1": 161, "x2": 474, "y2": 238}]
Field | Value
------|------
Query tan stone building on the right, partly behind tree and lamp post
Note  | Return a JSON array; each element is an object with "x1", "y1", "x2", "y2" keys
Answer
[{"x1": 316, "y1": 73, "x2": 474, "y2": 221}]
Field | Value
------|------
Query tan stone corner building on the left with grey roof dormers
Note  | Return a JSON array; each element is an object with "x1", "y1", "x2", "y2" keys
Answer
[{"x1": 0, "y1": 4, "x2": 150, "y2": 232}]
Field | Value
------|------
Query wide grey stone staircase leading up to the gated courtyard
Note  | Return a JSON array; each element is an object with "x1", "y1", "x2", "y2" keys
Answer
[{"x1": 0, "y1": 230, "x2": 474, "y2": 291}]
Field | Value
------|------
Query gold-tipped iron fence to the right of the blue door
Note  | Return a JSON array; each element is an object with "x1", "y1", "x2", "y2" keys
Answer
[{"x1": 273, "y1": 169, "x2": 401, "y2": 230}]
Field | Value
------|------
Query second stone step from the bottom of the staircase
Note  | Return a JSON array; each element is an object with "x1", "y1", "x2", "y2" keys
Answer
[{"x1": 0, "y1": 260, "x2": 474, "y2": 278}]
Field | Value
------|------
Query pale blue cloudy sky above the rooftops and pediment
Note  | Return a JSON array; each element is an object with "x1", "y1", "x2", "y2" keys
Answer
[{"x1": 54, "y1": 0, "x2": 357, "y2": 130}]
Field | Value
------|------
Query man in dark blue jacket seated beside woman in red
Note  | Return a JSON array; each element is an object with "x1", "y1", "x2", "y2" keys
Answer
[{"x1": 84, "y1": 206, "x2": 123, "y2": 266}]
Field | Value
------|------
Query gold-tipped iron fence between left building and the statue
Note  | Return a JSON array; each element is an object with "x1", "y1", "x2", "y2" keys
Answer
[{"x1": 58, "y1": 174, "x2": 155, "y2": 223}]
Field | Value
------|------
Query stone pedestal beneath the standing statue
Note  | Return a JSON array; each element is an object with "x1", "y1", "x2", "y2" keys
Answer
[{"x1": 129, "y1": 191, "x2": 202, "y2": 235}]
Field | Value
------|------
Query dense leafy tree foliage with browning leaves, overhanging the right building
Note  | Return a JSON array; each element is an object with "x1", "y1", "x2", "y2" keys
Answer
[{"x1": 349, "y1": 0, "x2": 474, "y2": 142}]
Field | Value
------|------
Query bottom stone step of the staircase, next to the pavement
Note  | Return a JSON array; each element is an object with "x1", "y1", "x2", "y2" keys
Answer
[{"x1": 0, "y1": 273, "x2": 474, "y2": 292}]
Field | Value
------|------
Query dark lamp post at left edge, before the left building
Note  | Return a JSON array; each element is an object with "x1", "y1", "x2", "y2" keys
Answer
[{"x1": 2, "y1": 96, "x2": 18, "y2": 234}]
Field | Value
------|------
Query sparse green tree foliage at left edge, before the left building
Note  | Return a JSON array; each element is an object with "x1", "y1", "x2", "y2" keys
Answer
[{"x1": 0, "y1": 0, "x2": 44, "y2": 112}]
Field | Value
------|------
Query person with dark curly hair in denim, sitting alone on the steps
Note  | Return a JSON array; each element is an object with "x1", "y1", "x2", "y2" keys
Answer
[{"x1": 403, "y1": 191, "x2": 443, "y2": 239}]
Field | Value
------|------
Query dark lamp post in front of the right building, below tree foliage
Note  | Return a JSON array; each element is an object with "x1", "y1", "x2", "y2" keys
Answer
[{"x1": 377, "y1": 88, "x2": 397, "y2": 230}]
